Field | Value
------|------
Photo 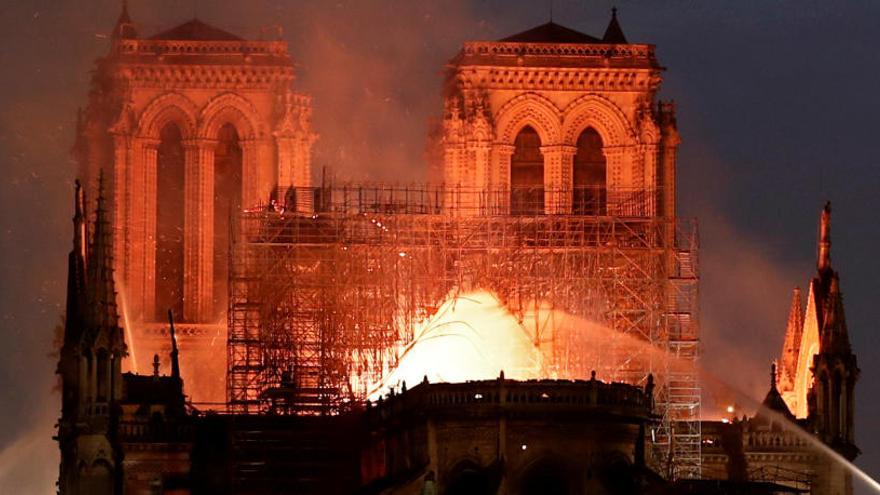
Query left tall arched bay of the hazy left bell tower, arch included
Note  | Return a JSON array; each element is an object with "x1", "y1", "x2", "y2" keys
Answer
[{"x1": 127, "y1": 93, "x2": 197, "y2": 321}]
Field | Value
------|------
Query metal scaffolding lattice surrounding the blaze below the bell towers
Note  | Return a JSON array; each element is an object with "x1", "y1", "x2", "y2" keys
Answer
[{"x1": 227, "y1": 185, "x2": 701, "y2": 478}]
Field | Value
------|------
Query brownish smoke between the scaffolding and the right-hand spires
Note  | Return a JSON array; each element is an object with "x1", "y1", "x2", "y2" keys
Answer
[{"x1": 700, "y1": 202, "x2": 812, "y2": 417}]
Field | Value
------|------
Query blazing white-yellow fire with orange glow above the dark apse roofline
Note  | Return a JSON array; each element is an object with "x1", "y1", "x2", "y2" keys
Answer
[{"x1": 369, "y1": 291, "x2": 657, "y2": 399}]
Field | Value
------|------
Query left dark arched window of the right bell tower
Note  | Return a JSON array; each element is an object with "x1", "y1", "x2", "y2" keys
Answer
[{"x1": 510, "y1": 126, "x2": 544, "y2": 215}]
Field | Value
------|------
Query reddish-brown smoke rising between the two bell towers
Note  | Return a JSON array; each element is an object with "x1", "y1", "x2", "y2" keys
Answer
[{"x1": 289, "y1": 0, "x2": 472, "y2": 181}]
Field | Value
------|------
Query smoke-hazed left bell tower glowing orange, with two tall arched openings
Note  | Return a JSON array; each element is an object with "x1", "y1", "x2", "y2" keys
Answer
[{"x1": 74, "y1": 5, "x2": 316, "y2": 400}]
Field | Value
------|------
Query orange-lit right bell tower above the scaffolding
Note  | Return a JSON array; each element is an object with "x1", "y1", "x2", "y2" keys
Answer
[{"x1": 436, "y1": 11, "x2": 679, "y2": 217}]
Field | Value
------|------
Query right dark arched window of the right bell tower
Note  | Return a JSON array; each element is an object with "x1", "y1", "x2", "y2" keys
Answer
[{"x1": 572, "y1": 127, "x2": 607, "y2": 215}]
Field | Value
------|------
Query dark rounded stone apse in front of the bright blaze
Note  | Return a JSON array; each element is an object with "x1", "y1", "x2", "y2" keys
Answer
[{"x1": 362, "y1": 374, "x2": 659, "y2": 495}]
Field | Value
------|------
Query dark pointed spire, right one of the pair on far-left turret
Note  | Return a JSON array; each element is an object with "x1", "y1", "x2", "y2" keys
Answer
[{"x1": 87, "y1": 172, "x2": 119, "y2": 336}]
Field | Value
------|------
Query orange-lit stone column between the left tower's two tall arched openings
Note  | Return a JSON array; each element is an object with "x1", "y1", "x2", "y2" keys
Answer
[{"x1": 183, "y1": 139, "x2": 215, "y2": 323}]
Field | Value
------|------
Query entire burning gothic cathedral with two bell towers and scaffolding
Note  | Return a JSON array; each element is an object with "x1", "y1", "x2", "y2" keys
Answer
[{"x1": 56, "y1": 7, "x2": 859, "y2": 495}]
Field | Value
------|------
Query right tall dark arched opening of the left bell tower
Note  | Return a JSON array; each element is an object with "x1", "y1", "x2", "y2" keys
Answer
[{"x1": 214, "y1": 124, "x2": 242, "y2": 316}]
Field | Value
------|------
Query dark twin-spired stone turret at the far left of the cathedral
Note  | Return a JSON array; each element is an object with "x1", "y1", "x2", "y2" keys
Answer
[{"x1": 57, "y1": 180, "x2": 126, "y2": 494}]
